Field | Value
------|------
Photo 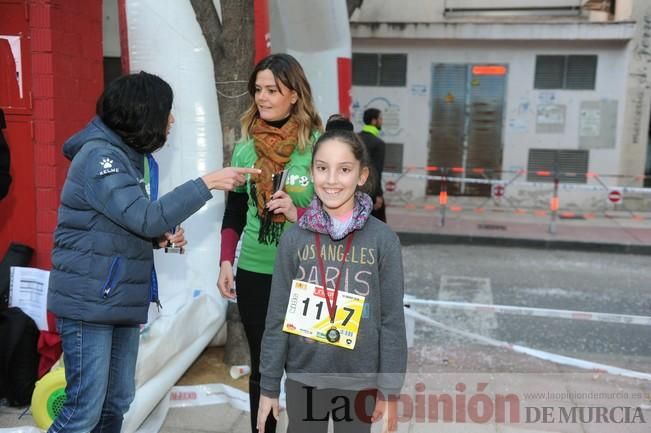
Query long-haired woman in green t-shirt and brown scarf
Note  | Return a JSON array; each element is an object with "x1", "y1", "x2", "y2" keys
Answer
[{"x1": 217, "y1": 54, "x2": 323, "y2": 433}]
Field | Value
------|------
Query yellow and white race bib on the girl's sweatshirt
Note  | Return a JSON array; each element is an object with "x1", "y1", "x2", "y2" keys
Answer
[{"x1": 283, "y1": 280, "x2": 364, "y2": 349}]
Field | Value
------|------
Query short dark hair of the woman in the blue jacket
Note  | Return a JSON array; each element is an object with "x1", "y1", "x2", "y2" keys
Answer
[{"x1": 97, "y1": 72, "x2": 174, "y2": 153}]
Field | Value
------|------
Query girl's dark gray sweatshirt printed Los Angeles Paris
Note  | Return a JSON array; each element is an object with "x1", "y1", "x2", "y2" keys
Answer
[{"x1": 260, "y1": 217, "x2": 407, "y2": 397}]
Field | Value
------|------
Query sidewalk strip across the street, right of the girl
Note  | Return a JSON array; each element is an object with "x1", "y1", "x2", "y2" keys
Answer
[{"x1": 387, "y1": 198, "x2": 651, "y2": 254}]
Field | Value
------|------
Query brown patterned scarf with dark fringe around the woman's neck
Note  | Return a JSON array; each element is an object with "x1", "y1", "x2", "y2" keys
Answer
[{"x1": 251, "y1": 118, "x2": 298, "y2": 245}]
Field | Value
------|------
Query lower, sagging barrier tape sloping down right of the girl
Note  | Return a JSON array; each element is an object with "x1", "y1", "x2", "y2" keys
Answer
[{"x1": 405, "y1": 308, "x2": 651, "y2": 381}]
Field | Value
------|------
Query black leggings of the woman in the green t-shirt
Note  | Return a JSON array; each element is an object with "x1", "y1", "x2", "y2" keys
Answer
[{"x1": 235, "y1": 269, "x2": 276, "y2": 433}]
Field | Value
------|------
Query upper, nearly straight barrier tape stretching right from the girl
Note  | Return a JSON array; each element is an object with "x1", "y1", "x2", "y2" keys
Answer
[{"x1": 404, "y1": 296, "x2": 651, "y2": 326}]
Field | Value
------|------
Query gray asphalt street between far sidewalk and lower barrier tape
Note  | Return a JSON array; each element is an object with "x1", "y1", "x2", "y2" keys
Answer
[{"x1": 403, "y1": 244, "x2": 651, "y2": 372}]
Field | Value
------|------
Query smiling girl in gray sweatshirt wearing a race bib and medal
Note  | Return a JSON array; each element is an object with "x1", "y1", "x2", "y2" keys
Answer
[{"x1": 258, "y1": 129, "x2": 407, "y2": 433}]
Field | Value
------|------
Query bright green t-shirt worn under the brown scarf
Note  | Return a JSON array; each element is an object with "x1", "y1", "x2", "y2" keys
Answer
[{"x1": 231, "y1": 134, "x2": 316, "y2": 274}]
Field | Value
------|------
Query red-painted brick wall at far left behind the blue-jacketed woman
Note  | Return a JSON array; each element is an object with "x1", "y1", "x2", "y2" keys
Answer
[{"x1": 0, "y1": 0, "x2": 103, "y2": 269}]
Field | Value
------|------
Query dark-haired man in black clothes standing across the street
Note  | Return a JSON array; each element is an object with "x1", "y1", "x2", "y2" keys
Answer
[{"x1": 359, "y1": 108, "x2": 387, "y2": 222}]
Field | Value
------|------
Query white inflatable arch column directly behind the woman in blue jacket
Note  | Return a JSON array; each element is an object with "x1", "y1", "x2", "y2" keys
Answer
[{"x1": 119, "y1": 0, "x2": 226, "y2": 433}]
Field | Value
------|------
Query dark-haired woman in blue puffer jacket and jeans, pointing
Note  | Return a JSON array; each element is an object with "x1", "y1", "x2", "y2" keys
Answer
[{"x1": 48, "y1": 72, "x2": 260, "y2": 433}]
